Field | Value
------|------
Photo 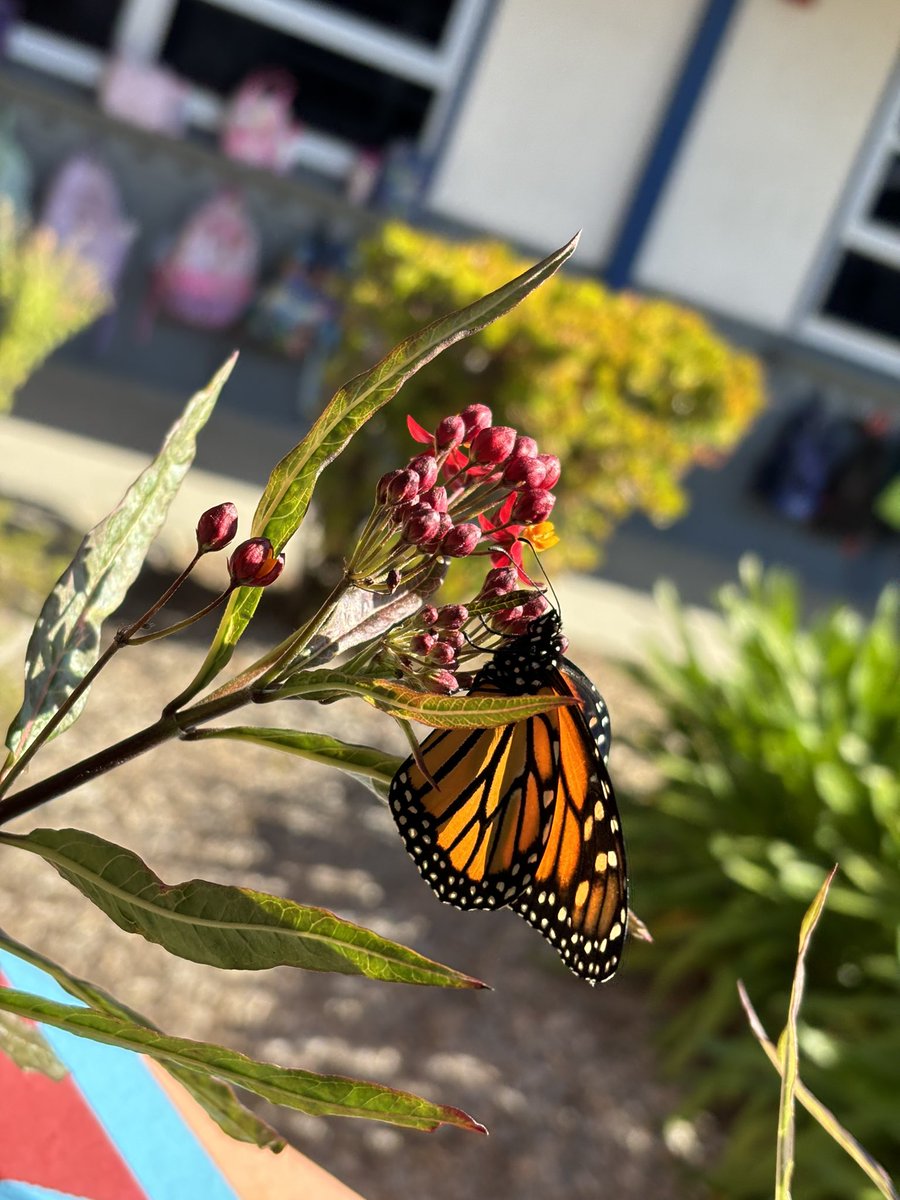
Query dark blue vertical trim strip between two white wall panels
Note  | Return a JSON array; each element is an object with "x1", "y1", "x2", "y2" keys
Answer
[{"x1": 604, "y1": 0, "x2": 740, "y2": 288}]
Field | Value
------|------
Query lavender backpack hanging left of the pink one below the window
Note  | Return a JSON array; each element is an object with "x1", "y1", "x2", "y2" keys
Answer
[{"x1": 38, "y1": 154, "x2": 138, "y2": 296}]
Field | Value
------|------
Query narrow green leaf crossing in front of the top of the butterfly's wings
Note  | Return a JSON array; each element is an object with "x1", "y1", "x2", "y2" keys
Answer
[{"x1": 271, "y1": 671, "x2": 572, "y2": 730}]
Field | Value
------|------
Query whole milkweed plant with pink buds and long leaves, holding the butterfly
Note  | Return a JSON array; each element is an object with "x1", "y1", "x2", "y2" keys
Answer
[{"x1": 0, "y1": 241, "x2": 600, "y2": 1148}]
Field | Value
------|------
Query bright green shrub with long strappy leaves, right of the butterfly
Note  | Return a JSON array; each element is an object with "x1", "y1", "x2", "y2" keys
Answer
[{"x1": 628, "y1": 560, "x2": 900, "y2": 1200}]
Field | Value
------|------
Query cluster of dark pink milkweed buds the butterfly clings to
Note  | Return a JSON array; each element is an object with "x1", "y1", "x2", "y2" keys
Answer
[{"x1": 347, "y1": 404, "x2": 560, "y2": 692}]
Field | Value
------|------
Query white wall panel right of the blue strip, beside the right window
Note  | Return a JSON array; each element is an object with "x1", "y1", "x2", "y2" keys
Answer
[{"x1": 636, "y1": 0, "x2": 900, "y2": 331}]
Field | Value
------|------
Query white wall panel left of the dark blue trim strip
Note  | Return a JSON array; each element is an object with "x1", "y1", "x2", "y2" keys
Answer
[{"x1": 430, "y1": 0, "x2": 705, "y2": 268}]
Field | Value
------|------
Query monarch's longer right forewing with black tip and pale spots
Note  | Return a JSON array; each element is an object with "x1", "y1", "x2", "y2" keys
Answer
[{"x1": 511, "y1": 660, "x2": 628, "y2": 984}]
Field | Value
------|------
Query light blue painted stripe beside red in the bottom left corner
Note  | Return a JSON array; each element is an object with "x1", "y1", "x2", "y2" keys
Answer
[{"x1": 0, "y1": 950, "x2": 238, "y2": 1200}]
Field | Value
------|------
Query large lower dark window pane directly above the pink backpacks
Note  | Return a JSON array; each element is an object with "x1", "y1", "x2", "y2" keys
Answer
[{"x1": 162, "y1": 0, "x2": 431, "y2": 146}]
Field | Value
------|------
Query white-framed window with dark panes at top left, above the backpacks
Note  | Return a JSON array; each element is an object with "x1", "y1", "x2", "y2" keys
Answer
[{"x1": 7, "y1": 0, "x2": 493, "y2": 178}]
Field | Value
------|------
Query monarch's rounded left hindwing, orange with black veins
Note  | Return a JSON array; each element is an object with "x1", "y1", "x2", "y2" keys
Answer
[{"x1": 389, "y1": 680, "x2": 559, "y2": 908}]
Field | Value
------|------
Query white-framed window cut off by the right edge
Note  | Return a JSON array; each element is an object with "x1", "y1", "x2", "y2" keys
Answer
[{"x1": 799, "y1": 59, "x2": 900, "y2": 370}]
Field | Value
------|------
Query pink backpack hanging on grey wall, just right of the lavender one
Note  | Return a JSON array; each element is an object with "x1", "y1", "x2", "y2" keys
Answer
[{"x1": 151, "y1": 191, "x2": 259, "y2": 329}]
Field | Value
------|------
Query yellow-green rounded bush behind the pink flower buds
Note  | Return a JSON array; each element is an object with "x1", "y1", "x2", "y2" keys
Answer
[{"x1": 322, "y1": 224, "x2": 763, "y2": 580}]
